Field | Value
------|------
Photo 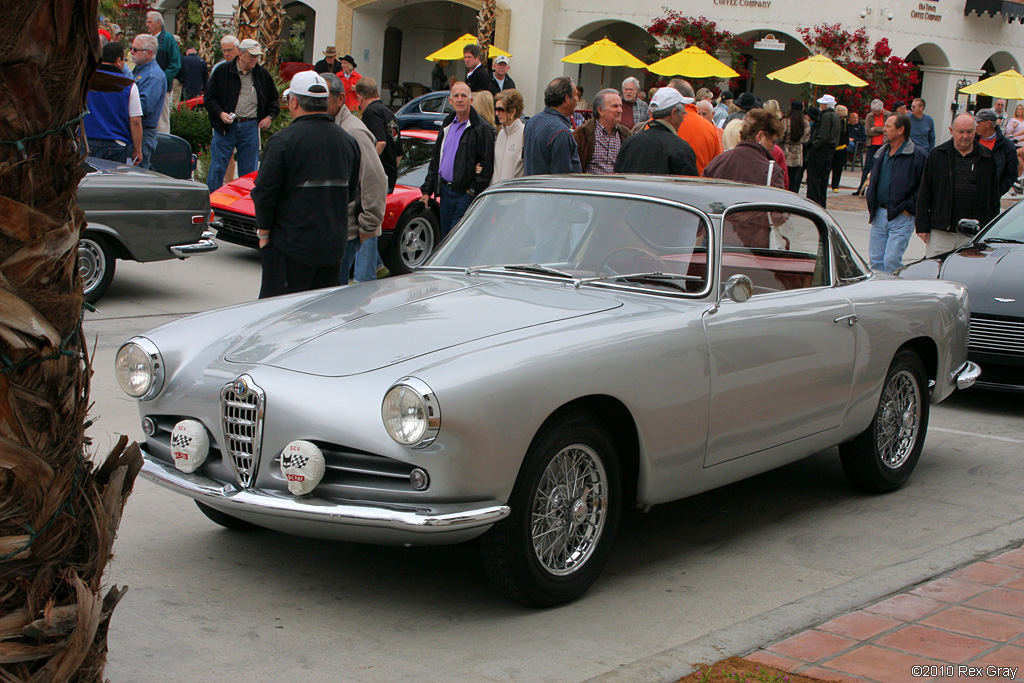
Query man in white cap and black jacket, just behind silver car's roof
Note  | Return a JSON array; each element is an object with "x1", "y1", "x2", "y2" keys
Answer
[{"x1": 615, "y1": 87, "x2": 697, "y2": 176}]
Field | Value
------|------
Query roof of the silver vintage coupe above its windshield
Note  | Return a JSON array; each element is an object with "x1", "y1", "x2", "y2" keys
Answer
[{"x1": 487, "y1": 175, "x2": 823, "y2": 215}]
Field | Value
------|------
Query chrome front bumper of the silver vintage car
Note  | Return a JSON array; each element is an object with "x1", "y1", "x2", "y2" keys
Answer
[{"x1": 141, "y1": 450, "x2": 510, "y2": 544}]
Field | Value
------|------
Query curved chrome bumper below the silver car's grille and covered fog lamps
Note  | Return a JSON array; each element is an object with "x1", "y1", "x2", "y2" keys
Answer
[{"x1": 141, "y1": 450, "x2": 511, "y2": 533}]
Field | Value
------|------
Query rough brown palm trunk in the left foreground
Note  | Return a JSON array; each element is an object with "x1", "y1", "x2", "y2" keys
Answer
[{"x1": 0, "y1": 0, "x2": 141, "y2": 681}]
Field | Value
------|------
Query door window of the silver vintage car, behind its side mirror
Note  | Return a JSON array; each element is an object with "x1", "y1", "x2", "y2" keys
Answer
[{"x1": 722, "y1": 208, "x2": 828, "y2": 295}]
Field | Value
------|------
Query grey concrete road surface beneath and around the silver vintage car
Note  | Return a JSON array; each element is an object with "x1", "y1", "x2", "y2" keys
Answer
[{"x1": 86, "y1": 202, "x2": 1024, "y2": 683}]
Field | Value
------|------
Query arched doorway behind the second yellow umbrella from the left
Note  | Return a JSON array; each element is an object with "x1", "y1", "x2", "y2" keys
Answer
[{"x1": 566, "y1": 19, "x2": 659, "y2": 102}]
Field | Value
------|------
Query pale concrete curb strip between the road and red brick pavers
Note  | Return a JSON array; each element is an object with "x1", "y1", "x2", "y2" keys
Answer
[{"x1": 588, "y1": 517, "x2": 1024, "y2": 683}]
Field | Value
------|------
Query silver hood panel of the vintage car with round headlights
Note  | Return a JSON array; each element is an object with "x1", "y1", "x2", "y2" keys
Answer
[{"x1": 224, "y1": 274, "x2": 622, "y2": 377}]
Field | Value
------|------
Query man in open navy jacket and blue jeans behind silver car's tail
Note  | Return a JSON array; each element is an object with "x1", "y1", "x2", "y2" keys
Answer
[{"x1": 864, "y1": 114, "x2": 928, "y2": 272}]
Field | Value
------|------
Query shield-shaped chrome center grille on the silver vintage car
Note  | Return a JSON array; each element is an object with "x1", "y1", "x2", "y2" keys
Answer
[{"x1": 220, "y1": 375, "x2": 264, "y2": 488}]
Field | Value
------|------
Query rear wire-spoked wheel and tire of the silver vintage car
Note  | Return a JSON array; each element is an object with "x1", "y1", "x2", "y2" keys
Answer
[{"x1": 839, "y1": 349, "x2": 930, "y2": 494}]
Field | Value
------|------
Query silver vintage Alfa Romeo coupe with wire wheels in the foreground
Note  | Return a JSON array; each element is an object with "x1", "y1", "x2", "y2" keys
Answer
[{"x1": 116, "y1": 176, "x2": 980, "y2": 605}]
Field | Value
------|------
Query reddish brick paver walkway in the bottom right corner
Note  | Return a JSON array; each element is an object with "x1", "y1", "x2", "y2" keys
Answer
[{"x1": 746, "y1": 548, "x2": 1024, "y2": 683}]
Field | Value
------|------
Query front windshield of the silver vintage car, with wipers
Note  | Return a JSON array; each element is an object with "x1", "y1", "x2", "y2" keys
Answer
[{"x1": 427, "y1": 190, "x2": 710, "y2": 294}]
